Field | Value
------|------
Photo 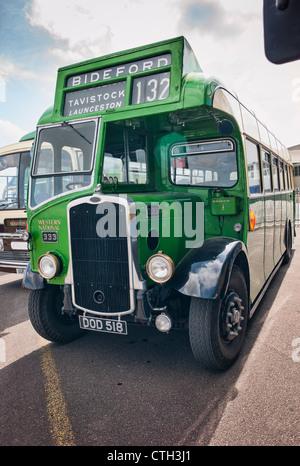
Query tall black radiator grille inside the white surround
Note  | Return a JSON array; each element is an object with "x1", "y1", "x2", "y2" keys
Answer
[{"x1": 70, "y1": 202, "x2": 130, "y2": 313}]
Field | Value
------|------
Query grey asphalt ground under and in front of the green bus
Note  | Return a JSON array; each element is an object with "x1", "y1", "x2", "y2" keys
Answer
[{"x1": 0, "y1": 237, "x2": 300, "y2": 448}]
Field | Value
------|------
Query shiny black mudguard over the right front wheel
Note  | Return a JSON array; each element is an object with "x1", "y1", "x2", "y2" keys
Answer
[{"x1": 170, "y1": 238, "x2": 249, "y2": 299}]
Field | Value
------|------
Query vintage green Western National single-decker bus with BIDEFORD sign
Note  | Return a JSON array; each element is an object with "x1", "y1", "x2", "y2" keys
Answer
[{"x1": 24, "y1": 37, "x2": 295, "y2": 369}]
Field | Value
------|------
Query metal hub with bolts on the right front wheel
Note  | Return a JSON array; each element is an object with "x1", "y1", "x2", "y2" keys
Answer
[{"x1": 222, "y1": 291, "x2": 244, "y2": 341}]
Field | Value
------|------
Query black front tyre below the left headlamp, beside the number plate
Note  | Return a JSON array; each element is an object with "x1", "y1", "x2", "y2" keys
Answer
[{"x1": 28, "y1": 286, "x2": 83, "y2": 343}]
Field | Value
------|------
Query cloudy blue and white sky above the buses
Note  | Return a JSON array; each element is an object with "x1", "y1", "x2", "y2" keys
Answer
[{"x1": 0, "y1": 0, "x2": 300, "y2": 147}]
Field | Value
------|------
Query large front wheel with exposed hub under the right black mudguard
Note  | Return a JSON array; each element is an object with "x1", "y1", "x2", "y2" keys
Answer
[{"x1": 189, "y1": 266, "x2": 248, "y2": 370}]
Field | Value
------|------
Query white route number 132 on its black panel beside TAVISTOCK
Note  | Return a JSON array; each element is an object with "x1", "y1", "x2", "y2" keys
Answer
[{"x1": 131, "y1": 72, "x2": 170, "y2": 104}]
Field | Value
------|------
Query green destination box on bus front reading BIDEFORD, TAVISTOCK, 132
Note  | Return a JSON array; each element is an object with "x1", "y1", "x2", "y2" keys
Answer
[{"x1": 48, "y1": 36, "x2": 210, "y2": 124}]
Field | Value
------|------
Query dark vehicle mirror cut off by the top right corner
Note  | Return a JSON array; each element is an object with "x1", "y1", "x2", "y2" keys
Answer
[{"x1": 263, "y1": 0, "x2": 300, "y2": 64}]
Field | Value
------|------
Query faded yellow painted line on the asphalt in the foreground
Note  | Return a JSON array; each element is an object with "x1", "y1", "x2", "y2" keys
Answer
[{"x1": 41, "y1": 345, "x2": 75, "y2": 446}]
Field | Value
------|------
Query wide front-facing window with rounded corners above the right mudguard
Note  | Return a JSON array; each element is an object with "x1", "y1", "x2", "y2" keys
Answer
[{"x1": 170, "y1": 139, "x2": 237, "y2": 188}]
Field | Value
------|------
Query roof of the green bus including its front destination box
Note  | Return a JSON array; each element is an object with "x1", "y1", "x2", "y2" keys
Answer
[{"x1": 38, "y1": 36, "x2": 290, "y2": 162}]
